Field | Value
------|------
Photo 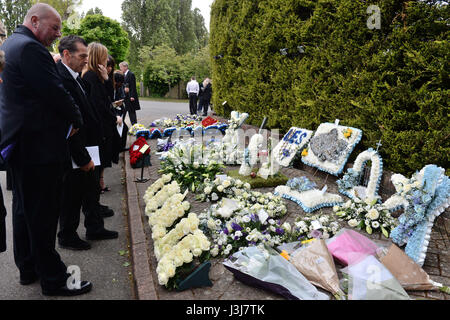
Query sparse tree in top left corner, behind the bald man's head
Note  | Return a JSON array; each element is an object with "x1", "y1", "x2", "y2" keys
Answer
[{"x1": 0, "y1": 0, "x2": 32, "y2": 35}]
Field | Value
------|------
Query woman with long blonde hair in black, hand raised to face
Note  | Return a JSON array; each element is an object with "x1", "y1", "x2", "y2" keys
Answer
[{"x1": 83, "y1": 42, "x2": 122, "y2": 198}]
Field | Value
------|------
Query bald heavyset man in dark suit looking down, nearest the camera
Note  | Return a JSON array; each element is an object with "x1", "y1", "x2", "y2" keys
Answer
[{"x1": 0, "y1": 3, "x2": 92, "y2": 296}]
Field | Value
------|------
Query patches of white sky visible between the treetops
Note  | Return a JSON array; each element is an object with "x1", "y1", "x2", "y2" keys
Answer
[{"x1": 79, "y1": 0, "x2": 214, "y2": 30}]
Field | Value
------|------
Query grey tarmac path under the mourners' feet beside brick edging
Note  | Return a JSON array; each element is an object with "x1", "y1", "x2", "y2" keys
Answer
[{"x1": 0, "y1": 150, "x2": 135, "y2": 300}]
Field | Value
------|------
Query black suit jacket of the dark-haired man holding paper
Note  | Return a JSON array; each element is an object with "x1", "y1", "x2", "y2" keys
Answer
[{"x1": 56, "y1": 61, "x2": 103, "y2": 167}]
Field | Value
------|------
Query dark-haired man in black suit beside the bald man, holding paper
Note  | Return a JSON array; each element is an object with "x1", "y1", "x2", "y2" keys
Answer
[{"x1": 56, "y1": 36, "x2": 118, "y2": 250}]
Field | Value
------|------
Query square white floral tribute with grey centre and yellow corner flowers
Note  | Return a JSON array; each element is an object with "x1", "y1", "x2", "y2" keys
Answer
[{"x1": 302, "y1": 120, "x2": 362, "y2": 176}]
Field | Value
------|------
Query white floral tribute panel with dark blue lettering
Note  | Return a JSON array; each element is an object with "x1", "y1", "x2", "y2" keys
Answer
[{"x1": 273, "y1": 127, "x2": 313, "y2": 167}]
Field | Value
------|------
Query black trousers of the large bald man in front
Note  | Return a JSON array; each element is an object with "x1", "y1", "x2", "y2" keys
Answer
[{"x1": 11, "y1": 163, "x2": 69, "y2": 290}]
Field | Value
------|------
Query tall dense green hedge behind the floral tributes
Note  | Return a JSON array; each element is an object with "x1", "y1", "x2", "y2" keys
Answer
[{"x1": 210, "y1": 0, "x2": 450, "y2": 174}]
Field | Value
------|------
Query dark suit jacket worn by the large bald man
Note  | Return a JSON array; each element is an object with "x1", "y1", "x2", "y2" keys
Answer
[{"x1": 0, "y1": 26, "x2": 83, "y2": 165}]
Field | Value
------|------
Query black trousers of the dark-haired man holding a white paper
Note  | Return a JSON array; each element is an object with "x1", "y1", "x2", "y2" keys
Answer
[{"x1": 58, "y1": 169, "x2": 104, "y2": 241}]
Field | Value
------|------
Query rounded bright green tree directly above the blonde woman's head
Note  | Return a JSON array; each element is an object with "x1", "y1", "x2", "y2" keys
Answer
[{"x1": 63, "y1": 14, "x2": 130, "y2": 62}]
